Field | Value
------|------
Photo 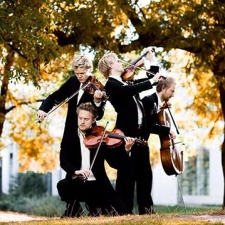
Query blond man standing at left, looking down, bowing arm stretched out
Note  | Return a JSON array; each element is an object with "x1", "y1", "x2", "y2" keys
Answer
[{"x1": 37, "y1": 54, "x2": 105, "y2": 135}]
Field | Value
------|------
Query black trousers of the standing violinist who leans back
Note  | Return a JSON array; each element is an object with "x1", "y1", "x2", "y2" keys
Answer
[{"x1": 116, "y1": 145, "x2": 153, "y2": 214}]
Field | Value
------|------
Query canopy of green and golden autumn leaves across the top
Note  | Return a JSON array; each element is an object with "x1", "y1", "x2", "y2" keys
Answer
[{"x1": 0, "y1": 0, "x2": 225, "y2": 84}]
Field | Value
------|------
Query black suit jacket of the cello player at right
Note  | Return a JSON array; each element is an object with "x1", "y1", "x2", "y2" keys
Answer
[{"x1": 142, "y1": 93, "x2": 170, "y2": 136}]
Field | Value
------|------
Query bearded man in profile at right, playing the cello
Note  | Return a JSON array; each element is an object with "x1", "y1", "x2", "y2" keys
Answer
[{"x1": 142, "y1": 75, "x2": 176, "y2": 138}]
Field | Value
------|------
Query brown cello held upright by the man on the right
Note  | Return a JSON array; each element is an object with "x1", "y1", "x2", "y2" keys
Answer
[{"x1": 158, "y1": 103, "x2": 184, "y2": 176}]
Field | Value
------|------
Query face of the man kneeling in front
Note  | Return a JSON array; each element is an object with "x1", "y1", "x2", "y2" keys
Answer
[{"x1": 78, "y1": 110, "x2": 95, "y2": 132}]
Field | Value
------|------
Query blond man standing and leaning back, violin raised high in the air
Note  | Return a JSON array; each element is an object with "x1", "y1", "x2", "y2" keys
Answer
[{"x1": 98, "y1": 51, "x2": 158, "y2": 214}]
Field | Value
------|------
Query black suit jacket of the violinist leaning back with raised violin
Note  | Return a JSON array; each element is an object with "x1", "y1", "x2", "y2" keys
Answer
[{"x1": 105, "y1": 77, "x2": 152, "y2": 137}]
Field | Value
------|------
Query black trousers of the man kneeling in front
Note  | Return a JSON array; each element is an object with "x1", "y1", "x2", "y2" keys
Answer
[{"x1": 57, "y1": 179, "x2": 128, "y2": 215}]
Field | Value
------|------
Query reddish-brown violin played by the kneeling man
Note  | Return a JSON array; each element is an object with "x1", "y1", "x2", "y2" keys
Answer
[{"x1": 84, "y1": 126, "x2": 147, "y2": 149}]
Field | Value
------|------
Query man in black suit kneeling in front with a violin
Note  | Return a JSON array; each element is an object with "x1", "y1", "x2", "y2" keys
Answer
[{"x1": 57, "y1": 102, "x2": 134, "y2": 217}]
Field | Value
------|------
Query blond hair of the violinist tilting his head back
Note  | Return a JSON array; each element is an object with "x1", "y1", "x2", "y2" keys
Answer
[{"x1": 98, "y1": 53, "x2": 118, "y2": 78}]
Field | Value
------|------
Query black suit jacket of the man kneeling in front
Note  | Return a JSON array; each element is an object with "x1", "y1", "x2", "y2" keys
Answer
[{"x1": 60, "y1": 130, "x2": 129, "y2": 191}]
